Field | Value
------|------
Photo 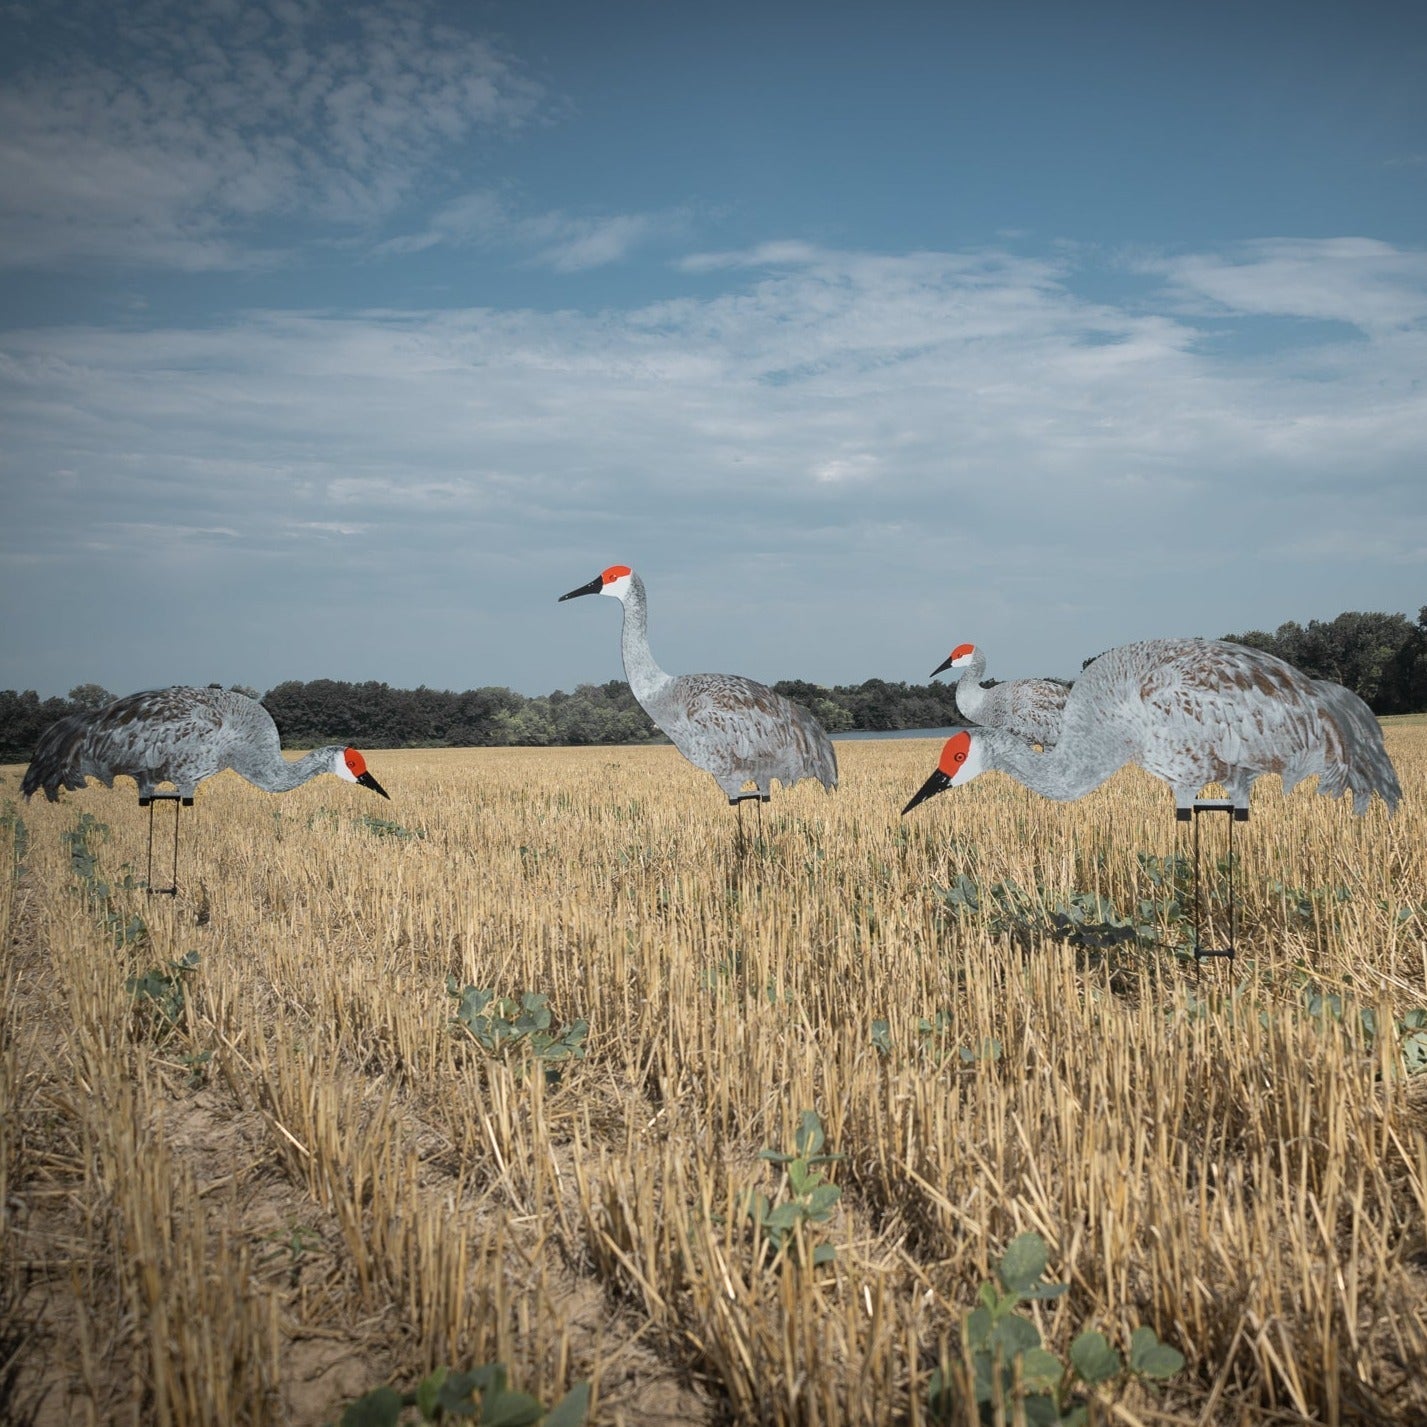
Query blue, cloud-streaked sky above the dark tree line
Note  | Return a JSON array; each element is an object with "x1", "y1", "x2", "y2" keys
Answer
[{"x1": 0, "y1": 0, "x2": 1427, "y2": 696}]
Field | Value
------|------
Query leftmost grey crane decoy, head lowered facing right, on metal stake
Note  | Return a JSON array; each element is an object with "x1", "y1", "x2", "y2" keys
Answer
[{"x1": 20, "y1": 685, "x2": 391, "y2": 892}]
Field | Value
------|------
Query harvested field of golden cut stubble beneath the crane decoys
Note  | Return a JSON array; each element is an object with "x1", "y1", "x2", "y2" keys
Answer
[{"x1": 0, "y1": 721, "x2": 1427, "y2": 1427}]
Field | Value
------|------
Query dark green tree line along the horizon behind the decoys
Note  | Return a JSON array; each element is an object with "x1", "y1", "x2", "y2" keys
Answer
[{"x1": 0, "y1": 605, "x2": 1427, "y2": 763}]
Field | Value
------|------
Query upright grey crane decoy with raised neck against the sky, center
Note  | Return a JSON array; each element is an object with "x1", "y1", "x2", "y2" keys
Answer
[{"x1": 559, "y1": 565, "x2": 838, "y2": 813}]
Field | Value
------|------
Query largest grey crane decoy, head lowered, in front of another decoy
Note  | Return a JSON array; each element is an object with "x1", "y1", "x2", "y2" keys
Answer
[{"x1": 902, "y1": 639, "x2": 1401, "y2": 821}]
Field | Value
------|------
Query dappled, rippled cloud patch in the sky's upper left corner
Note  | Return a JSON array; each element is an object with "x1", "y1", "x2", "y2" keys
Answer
[{"x1": 0, "y1": 0, "x2": 541, "y2": 270}]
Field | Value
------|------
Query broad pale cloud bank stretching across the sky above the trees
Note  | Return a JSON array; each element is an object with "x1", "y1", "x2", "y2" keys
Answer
[{"x1": 0, "y1": 245, "x2": 1427, "y2": 691}]
